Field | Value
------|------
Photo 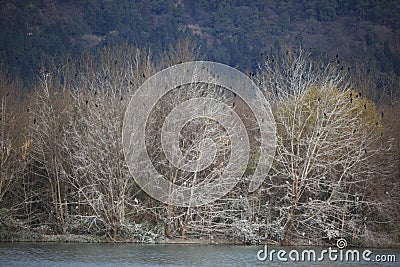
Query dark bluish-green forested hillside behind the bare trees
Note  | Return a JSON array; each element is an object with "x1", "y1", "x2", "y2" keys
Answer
[{"x1": 0, "y1": 0, "x2": 400, "y2": 84}]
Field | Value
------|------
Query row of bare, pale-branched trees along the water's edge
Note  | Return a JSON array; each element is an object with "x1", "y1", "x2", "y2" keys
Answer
[{"x1": 0, "y1": 42, "x2": 400, "y2": 246}]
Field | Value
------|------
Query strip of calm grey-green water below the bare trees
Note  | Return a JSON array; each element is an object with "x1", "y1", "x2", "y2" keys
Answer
[{"x1": 0, "y1": 243, "x2": 400, "y2": 267}]
